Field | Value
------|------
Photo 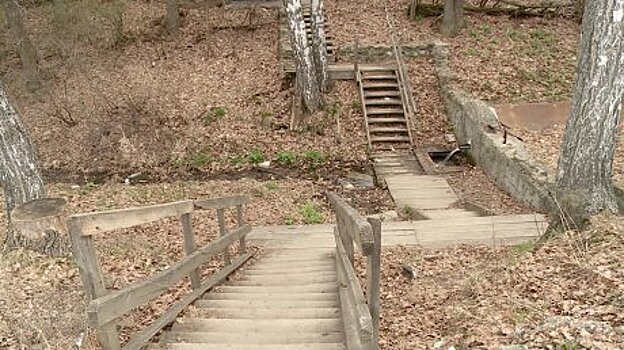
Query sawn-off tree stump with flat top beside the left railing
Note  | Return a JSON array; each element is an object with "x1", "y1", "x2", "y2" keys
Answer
[{"x1": 11, "y1": 197, "x2": 70, "y2": 257}]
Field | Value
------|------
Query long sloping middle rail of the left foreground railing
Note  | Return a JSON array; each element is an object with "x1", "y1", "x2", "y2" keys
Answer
[{"x1": 88, "y1": 225, "x2": 251, "y2": 325}]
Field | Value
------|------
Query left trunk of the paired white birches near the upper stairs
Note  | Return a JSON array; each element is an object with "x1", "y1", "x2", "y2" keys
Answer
[{"x1": 286, "y1": 0, "x2": 321, "y2": 124}]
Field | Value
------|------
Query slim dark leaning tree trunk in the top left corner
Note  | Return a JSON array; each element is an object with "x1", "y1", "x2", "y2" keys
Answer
[{"x1": 0, "y1": 0, "x2": 41, "y2": 91}]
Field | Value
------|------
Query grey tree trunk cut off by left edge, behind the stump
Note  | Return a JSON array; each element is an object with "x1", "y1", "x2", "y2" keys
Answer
[{"x1": 0, "y1": 83, "x2": 44, "y2": 248}]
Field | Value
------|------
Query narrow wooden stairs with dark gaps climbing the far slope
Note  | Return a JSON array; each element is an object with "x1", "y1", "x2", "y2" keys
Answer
[{"x1": 356, "y1": 66, "x2": 412, "y2": 151}]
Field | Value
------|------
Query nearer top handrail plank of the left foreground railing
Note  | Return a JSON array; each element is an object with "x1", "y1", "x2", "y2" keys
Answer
[{"x1": 67, "y1": 201, "x2": 193, "y2": 236}]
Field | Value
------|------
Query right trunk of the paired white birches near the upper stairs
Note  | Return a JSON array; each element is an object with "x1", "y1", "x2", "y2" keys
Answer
[{"x1": 310, "y1": 0, "x2": 330, "y2": 92}]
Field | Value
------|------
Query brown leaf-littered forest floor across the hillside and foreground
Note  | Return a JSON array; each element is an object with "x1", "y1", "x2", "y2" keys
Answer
[{"x1": 0, "y1": 0, "x2": 624, "y2": 349}]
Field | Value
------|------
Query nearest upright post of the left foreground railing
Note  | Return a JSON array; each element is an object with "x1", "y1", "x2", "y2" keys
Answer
[{"x1": 67, "y1": 219, "x2": 121, "y2": 350}]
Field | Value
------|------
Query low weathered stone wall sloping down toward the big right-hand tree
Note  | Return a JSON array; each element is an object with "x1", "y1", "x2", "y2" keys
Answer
[{"x1": 431, "y1": 43, "x2": 554, "y2": 212}]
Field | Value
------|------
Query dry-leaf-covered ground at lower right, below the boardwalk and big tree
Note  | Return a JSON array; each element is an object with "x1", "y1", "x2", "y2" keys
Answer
[{"x1": 366, "y1": 217, "x2": 624, "y2": 349}]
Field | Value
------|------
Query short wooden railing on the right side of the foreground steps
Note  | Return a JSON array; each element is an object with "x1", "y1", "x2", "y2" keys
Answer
[{"x1": 327, "y1": 193, "x2": 381, "y2": 350}]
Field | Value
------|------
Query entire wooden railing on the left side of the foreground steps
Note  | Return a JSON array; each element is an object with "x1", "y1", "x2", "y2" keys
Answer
[{"x1": 67, "y1": 196, "x2": 251, "y2": 350}]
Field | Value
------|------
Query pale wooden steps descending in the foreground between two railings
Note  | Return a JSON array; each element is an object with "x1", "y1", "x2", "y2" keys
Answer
[{"x1": 154, "y1": 238, "x2": 346, "y2": 350}]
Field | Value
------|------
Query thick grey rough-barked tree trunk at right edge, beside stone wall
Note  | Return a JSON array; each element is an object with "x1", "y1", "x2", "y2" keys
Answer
[{"x1": 557, "y1": 0, "x2": 624, "y2": 225}]
